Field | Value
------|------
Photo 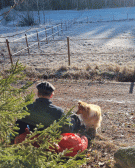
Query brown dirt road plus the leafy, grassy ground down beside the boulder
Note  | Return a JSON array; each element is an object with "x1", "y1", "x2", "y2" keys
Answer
[{"x1": 29, "y1": 79, "x2": 135, "y2": 168}]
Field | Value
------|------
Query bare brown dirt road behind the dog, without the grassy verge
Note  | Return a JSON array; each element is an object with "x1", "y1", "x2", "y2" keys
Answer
[{"x1": 45, "y1": 80, "x2": 135, "y2": 145}]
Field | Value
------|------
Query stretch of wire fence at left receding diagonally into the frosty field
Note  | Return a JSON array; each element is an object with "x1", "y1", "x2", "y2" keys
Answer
[{"x1": 0, "y1": 17, "x2": 76, "y2": 67}]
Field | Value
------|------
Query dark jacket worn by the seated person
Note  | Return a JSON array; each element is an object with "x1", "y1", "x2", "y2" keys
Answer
[{"x1": 16, "y1": 98, "x2": 64, "y2": 134}]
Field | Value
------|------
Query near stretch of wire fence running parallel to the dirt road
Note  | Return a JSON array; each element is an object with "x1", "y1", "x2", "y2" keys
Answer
[{"x1": 1, "y1": 36, "x2": 135, "y2": 71}]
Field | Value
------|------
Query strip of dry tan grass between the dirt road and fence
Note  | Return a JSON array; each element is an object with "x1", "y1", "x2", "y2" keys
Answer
[{"x1": 5, "y1": 63, "x2": 135, "y2": 82}]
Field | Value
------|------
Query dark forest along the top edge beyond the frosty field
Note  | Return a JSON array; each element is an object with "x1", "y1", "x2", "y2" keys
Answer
[{"x1": 0, "y1": 0, "x2": 135, "y2": 10}]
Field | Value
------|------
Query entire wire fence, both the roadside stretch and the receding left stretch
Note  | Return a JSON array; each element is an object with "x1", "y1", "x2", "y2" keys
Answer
[{"x1": 0, "y1": 15, "x2": 135, "y2": 72}]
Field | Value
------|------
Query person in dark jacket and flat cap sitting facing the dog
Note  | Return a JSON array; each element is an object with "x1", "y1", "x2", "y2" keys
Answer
[{"x1": 16, "y1": 81, "x2": 84, "y2": 134}]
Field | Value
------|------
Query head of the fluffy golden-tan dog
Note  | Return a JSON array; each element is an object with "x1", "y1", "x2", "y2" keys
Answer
[{"x1": 76, "y1": 101, "x2": 90, "y2": 118}]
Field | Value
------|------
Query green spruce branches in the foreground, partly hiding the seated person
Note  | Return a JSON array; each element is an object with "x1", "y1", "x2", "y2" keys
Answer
[{"x1": 0, "y1": 62, "x2": 86, "y2": 168}]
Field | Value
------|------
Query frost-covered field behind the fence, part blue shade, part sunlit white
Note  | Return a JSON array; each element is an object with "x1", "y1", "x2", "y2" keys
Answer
[{"x1": 0, "y1": 7, "x2": 135, "y2": 68}]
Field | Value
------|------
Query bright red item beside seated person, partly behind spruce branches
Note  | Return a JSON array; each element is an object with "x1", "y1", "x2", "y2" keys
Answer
[{"x1": 14, "y1": 131, "x2": 88, "y2": 156}]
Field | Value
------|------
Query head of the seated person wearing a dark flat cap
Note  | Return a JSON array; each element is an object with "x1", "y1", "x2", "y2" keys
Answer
[{"x1": 36, "y1": 81, "x2": 55, "y2": 98}]
